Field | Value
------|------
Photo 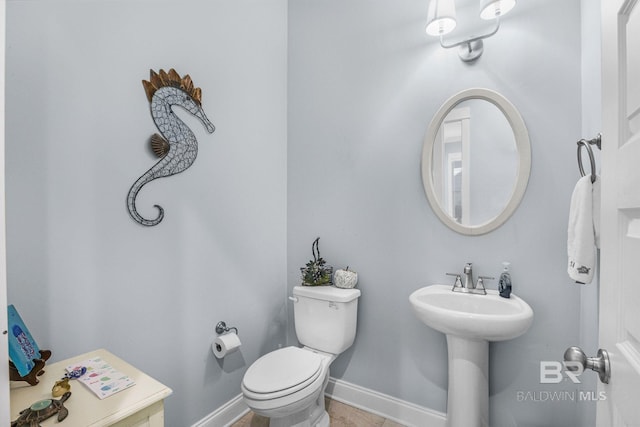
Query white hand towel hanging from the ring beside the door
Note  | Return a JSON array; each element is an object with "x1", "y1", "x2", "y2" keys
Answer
[{"x1": 567, "y1": 175, "x2": 600, "y2": 283}]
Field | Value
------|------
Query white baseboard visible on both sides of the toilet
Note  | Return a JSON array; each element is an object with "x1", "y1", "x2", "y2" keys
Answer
[{"x1": 192, "y1": 378, "x2": 447, "y2": 427}]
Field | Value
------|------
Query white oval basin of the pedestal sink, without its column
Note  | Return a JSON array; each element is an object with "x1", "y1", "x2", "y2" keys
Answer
[{"x1": 409, "y1": 285, "x2": 533, "y2": 341}]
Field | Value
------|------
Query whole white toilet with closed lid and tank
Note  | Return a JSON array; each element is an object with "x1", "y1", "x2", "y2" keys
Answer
[{"x1": 242, "y1": 286, "x2": 360, "y2": 427}]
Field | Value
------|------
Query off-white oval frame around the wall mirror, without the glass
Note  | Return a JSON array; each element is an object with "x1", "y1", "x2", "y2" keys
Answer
[{"x1": 421, "y1": 88, "x2": 531, "y2": 236}]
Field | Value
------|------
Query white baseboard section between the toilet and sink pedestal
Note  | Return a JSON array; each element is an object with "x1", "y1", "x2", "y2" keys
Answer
[{"x1": 325, "y1": 378, "x2": 447, "y2": 427}]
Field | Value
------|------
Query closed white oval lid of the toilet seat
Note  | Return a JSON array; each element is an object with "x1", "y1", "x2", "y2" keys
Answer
[{"x1": 243, "y1": 347, "x2": 322, "y2": 394}]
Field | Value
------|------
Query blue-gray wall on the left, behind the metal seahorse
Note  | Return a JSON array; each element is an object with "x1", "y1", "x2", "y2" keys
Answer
[{"x1": 6, "y1": 0, "x2": 287, "y2": 426}]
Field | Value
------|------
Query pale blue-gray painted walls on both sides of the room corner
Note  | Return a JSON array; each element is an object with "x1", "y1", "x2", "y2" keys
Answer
[{"x1": 6, "y1": 0, "x2": 593, "y2": 427}]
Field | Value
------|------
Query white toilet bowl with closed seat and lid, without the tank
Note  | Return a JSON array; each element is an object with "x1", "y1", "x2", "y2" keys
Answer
[{"x1": 241, "y1": 347, "x2": 335, "y2": 427}]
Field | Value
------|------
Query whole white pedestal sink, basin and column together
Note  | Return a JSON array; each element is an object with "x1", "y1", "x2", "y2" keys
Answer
[{"x1": 409, "y1": 285, "x2": 533, "y2": 427}]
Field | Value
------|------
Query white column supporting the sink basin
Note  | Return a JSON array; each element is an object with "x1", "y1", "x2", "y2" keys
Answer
[{"x1": 447, "y1": 335, "x2": 489, "y2": 427}]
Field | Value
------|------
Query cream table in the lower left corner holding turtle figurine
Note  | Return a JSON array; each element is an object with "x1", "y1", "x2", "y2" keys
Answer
[{"x1": 11, "y1": 349, "x2": 172, "y2": 427}]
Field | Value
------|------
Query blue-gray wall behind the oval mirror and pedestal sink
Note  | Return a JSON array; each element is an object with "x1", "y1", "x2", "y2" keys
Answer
[{"x1": 287, "y1": 0, "x2": 584, "y2": 427}]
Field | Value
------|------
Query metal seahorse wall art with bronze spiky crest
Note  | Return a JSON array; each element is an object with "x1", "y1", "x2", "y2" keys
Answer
[{"x1": 127, "y1": 68, "x2": 215, "y2": 226}]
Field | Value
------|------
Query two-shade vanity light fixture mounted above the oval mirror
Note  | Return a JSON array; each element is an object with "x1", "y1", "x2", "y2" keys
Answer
[{"x1": 426, "y1": 0, "x2": 516, "y2": 62}]
